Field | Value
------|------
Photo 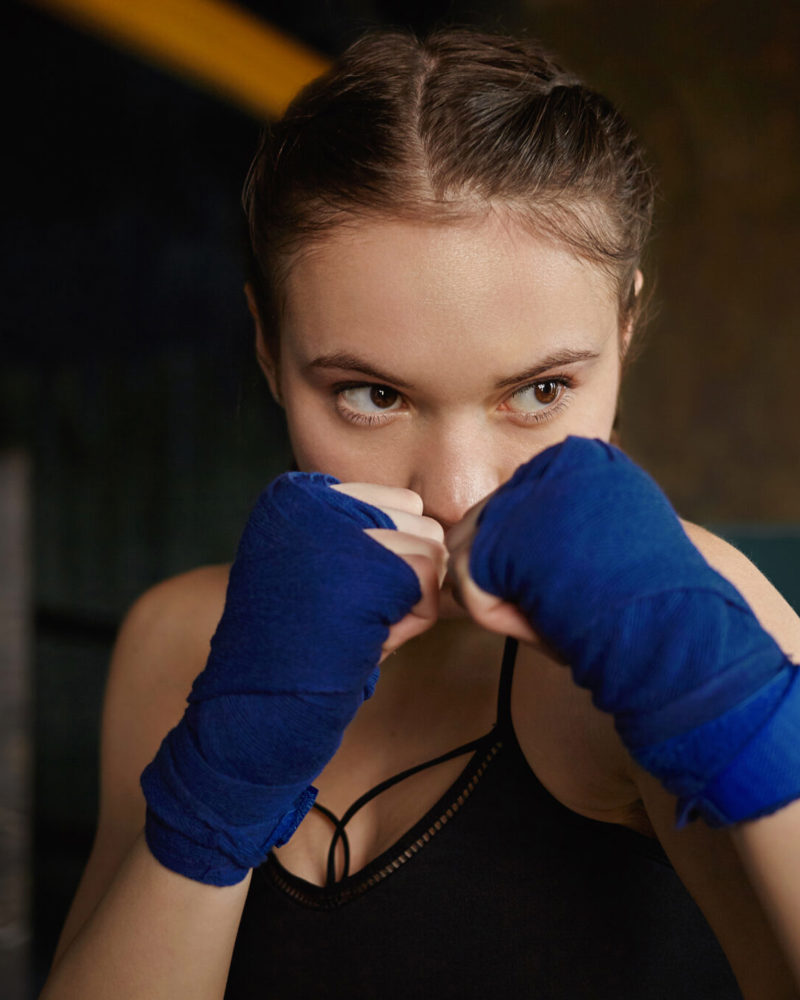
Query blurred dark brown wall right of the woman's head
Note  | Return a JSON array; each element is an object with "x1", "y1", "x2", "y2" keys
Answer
[{"x1": 522, "y1": 0, "x2": 800, "y2": 524}]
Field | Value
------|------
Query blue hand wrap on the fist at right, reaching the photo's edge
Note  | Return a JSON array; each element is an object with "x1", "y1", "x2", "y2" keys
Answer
[{"x1": 470, "y1": 438, "x2": 800, "y2": 826}]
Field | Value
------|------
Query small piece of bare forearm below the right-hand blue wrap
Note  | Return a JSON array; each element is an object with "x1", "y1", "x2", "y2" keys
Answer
[{"x1": 732, "y1": 800, "x2": 800, "y2": 987}]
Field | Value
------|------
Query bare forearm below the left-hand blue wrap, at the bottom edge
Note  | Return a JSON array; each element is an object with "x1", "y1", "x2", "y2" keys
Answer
[{"x1": 41, "y1": 836, "x2": 249, "y2": 1000}]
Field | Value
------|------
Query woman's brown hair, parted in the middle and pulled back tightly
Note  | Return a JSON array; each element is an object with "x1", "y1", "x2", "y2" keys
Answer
[{"x1": 243, "y1": 28, "x2": 653, "y2": 356}]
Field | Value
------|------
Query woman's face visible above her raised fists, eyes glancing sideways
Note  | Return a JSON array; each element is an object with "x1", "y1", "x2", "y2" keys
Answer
[{"x1": 262, "y1": 216, "x2": 620, "y2": 529}]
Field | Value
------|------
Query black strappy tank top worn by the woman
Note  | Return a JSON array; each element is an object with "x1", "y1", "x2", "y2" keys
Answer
[{"x1": 225, "y1": 640, "x2": 741, "y2": 1000}]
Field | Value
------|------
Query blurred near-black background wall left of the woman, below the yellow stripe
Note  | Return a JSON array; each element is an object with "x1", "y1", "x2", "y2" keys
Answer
[{"x1": 0, "y1": 4, "x2": 289, "y2": 994}]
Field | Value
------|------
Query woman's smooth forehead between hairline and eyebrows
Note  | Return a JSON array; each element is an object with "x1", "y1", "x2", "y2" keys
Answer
[{"x1": 281, "y1": 214, "x2": 617, "y2": 367}]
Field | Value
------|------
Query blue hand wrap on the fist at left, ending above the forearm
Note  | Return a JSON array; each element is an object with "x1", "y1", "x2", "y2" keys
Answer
[{"x1": 142, "y1": 472, "x2": 421, "y2": 885}]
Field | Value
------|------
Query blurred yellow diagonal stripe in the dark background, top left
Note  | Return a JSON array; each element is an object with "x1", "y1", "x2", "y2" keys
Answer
[{"x1": 28, "y1": 0, "x2": 327, "y2": 118}]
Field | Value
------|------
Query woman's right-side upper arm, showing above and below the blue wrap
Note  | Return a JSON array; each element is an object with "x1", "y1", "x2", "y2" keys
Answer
[{"x1": 632, "y1": 524, "x2": 800, "y2": 1000}]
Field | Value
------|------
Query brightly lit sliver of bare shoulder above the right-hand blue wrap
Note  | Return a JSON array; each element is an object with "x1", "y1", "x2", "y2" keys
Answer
[{"x1": 683, "y1": 521, "x2": 800, "y2": 661}]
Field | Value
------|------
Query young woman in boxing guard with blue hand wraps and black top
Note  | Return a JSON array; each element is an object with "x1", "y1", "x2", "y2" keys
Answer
[{"x1": 44, "y1": 31, "x2": 800, "y2": 1000}]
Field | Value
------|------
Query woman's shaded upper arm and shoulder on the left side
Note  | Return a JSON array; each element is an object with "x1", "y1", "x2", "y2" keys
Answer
[{"x1": 56, "y1": 566, "x2": 227, "y2": 955}]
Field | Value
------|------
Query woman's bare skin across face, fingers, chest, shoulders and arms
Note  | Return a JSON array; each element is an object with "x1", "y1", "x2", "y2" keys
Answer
[{"x1": 43, "y1": 213, "x2": 800, "y2": 1000}]
